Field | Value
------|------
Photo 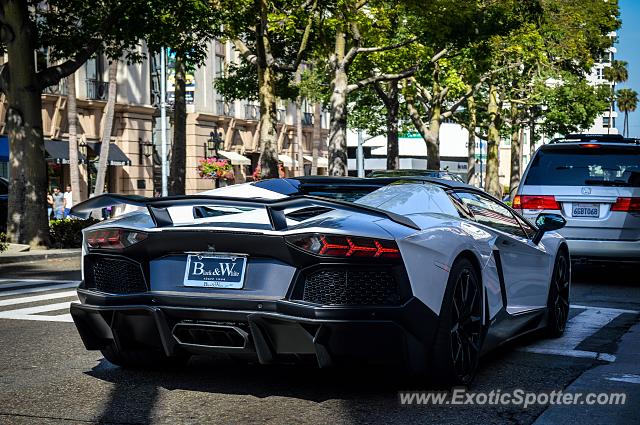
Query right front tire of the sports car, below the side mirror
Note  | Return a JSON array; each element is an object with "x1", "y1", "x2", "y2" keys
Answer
[{"x1": 546, "y1": 250, "x2": 571, "y2": 338}]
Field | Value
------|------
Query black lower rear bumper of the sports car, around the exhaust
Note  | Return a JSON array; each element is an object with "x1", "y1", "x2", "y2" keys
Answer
[{"x1": 71, "y1": 290, "x2": 437, "y2": 370}]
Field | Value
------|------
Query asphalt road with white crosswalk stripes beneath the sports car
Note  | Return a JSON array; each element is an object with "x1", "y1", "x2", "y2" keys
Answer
[{"x1": 0, "y1": 260, "x2": 640, "y2": 424}]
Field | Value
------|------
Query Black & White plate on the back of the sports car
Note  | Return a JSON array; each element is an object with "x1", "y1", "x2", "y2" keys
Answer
[{"x1": 184, "y1": 254, "x2": 247, "y2": 289}]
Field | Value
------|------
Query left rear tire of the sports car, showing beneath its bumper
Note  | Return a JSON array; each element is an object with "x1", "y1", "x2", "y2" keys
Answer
[{"x1": 100, "y1": 343, "x2": 190, "y2": 369}]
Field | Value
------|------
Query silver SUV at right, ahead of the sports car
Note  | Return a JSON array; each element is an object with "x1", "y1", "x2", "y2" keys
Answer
[{"x1": 513, "y1": 134, "x2": 640, "y2": 261}]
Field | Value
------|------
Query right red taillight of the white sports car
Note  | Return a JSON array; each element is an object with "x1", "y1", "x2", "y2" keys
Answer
[{"x1": 287, "y1": 234, "x2": 400, "y2": 258}]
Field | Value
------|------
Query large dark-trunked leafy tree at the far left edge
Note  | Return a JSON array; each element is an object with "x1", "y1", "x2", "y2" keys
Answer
[{"x1": 0, "y1": 0, "x2": 161, "y2": 246}]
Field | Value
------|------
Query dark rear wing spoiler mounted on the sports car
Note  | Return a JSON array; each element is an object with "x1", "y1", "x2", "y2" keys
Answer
[{"x1": 71, "y1": 193, "x2": 420, "y2": 230}]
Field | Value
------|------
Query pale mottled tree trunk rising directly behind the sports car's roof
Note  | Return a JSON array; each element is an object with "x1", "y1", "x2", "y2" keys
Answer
[{"x1": 329, "y1": 29, "x2": 349, "y2": 176}]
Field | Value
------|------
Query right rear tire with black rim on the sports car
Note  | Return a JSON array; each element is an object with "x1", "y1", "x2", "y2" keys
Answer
[{"x1": 429, "y1": 258, "x2": 486, "y2": 388}]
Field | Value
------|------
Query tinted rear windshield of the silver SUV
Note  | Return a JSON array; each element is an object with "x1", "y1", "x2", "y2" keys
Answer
[{"x1": 524, "y1": 146, "x2": 640, "y2": 187}]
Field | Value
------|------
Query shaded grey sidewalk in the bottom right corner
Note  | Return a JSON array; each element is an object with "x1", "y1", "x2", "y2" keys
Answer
[{"x1": 534, "y1": 323, "x2": 640, "y2": 425}]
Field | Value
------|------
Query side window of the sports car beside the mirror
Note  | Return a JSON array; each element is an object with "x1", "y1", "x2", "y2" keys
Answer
[{"x1": 455, "y1": 191, "x2": 528, "y2": 238}]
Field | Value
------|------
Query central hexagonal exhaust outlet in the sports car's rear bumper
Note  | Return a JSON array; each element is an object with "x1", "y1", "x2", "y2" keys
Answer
[{"x1": 172, "y1": 322, "x2": 249, "y2": 352}]
